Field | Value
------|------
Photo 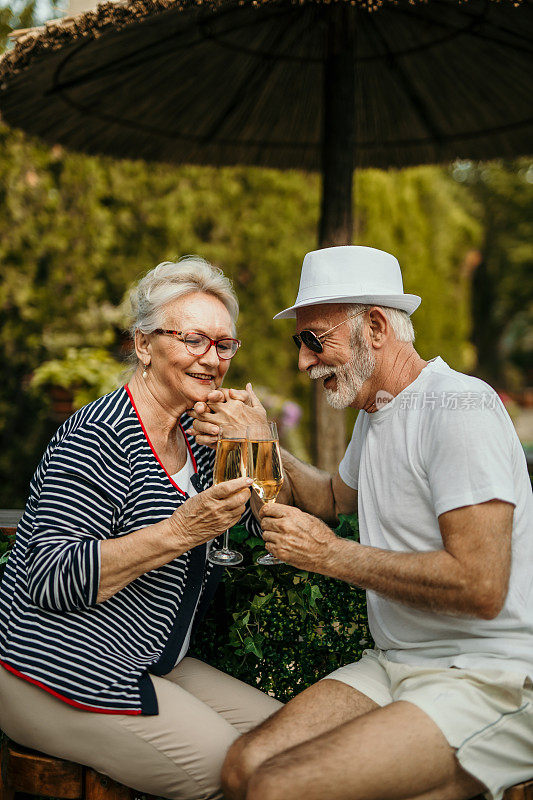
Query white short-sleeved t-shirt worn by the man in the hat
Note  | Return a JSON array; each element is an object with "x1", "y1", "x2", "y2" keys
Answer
[{"x1": 339, "y1": 358, "x2": 533, "y2": 678}]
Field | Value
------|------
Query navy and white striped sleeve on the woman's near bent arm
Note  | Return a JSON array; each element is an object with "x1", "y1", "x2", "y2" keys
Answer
[{"x1": 26, "y1": 424, "x2": 130, "y2": 611}]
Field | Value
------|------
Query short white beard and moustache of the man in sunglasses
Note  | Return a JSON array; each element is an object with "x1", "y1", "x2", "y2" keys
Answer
[{"x1": 308, "y1": 332, "x2": 376, "y2": 410}]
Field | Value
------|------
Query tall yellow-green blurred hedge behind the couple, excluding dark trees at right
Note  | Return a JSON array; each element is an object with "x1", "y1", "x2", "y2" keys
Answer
[{"x1": 0, "y1": 111, "x2": 528, "y2": 505}]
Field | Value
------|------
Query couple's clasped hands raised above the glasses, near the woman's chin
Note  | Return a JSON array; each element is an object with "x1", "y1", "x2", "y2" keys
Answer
[{"x1": 188, "y1": 383, "x2": 267, "y2": 447}]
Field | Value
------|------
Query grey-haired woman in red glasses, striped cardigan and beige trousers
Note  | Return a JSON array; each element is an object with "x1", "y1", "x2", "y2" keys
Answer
[{"x1": 0, "y1": 257, "x2": 280, "y2": 800}]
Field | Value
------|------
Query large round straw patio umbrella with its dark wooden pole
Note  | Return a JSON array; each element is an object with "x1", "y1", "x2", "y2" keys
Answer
[{"x1": 0, "y1": 0, "x2": 533, "y2": 469}]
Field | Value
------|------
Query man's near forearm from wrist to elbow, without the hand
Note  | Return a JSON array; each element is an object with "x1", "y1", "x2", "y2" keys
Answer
[{"x1": 315, "y1": 537, "x2": 499, "y2": 619}]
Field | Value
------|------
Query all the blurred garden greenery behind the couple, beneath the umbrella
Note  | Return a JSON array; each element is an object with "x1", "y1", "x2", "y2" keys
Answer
[{"x1": 0, "y1": 2, "x2": 533, "y2": 507}]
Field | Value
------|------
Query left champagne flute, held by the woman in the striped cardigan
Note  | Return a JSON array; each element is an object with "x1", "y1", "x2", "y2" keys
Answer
[{"x1": 207, "y1": 427, "x2": 248, "y2": 567}]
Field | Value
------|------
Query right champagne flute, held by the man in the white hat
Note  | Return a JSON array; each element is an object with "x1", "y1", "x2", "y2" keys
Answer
[{"x1": 246, "y1": 422, "x2": 283, "y2": 565}]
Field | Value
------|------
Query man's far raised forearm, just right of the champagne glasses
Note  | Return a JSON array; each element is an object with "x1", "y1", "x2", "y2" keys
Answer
[{"x1": 278, "y1": 448, "x2": 336, "y2": 522}]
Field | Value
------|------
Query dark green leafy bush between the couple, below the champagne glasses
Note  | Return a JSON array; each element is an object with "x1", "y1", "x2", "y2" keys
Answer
[{"x1": 0, "y1": 516, "x2": 372, "y2": 701}]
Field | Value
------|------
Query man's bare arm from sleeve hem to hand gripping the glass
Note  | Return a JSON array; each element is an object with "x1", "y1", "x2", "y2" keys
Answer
[{"x1": 261, "y1": 500, "x2": 514, "y2": 619}]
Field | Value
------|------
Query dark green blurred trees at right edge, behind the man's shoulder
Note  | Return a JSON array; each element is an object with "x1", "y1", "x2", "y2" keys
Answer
[{"x1": 448, "y1": 159, "x2": 533, "y2": 389}]
